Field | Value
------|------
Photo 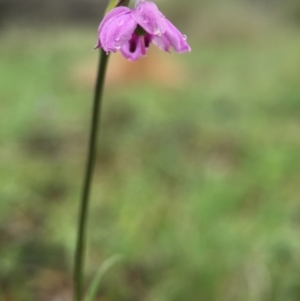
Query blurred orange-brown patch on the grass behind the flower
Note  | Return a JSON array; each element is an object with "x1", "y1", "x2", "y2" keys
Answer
[{"x1": 71, "y1": 47, "x2": 187, "y2": 88}]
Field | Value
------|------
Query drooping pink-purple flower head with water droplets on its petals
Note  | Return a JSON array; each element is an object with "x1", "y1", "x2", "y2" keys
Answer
[{"x1": 95, "y1": 0, "x2": 191, "y2": 61}]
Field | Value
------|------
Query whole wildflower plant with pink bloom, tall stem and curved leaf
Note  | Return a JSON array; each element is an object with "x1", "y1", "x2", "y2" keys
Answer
[{"x1": 74, "y1": 0, "x2": 191, "y2": 301}]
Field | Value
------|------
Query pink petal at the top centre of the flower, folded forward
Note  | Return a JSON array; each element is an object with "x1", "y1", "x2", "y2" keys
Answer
[{"x1": 131, "y1": 1, "x2": 167, "y2": 36}]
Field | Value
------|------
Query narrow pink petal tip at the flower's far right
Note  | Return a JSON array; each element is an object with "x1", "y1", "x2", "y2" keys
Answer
[{"x1": 164, "y1": 20, "x2": 191, "y2": 53}]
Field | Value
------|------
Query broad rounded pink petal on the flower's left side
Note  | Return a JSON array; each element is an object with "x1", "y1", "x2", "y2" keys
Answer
[{"x1": 99, "y1": 12, "x2": 137, "y2": 52}]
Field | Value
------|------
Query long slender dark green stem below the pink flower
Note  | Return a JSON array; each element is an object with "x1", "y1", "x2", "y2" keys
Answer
[{"x1": 74, "y1": 49, "x2": 108, "y2": 301}]
